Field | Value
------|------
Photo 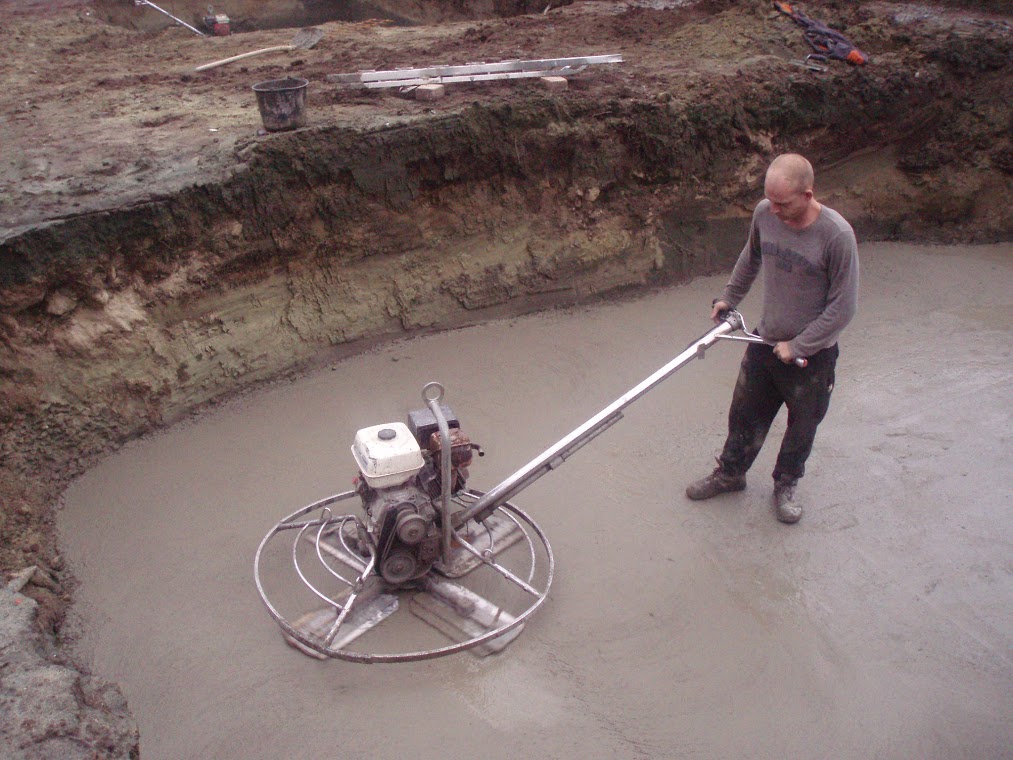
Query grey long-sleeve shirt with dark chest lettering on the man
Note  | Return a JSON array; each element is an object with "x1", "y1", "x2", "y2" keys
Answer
[{"x1": 721, "y1": 200, "x2": 858, "y2": 357}]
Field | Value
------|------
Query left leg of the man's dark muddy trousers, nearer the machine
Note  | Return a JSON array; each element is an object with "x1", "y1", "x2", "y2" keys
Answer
[{"x1": 719, "y1": 345, "x2": 784, "y2": 475}]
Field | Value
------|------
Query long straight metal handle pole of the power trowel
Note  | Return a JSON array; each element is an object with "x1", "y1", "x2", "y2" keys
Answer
[{"x1": 454, "y1": 311, "x2": 743, "y2": 525}]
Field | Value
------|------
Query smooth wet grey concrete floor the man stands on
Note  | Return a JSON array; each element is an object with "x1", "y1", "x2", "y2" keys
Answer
[{"x1": 59, "y1": 244, "x2": 1013, "y2": 760}]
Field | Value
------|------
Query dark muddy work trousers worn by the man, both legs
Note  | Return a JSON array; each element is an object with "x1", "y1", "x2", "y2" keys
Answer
[{"x1": 720, "y1": 344, "x2": 840, "y2": 480}]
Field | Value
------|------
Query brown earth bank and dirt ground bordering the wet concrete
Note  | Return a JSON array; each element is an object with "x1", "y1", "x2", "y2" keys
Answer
[{"x1": 0, "y1": 1, "x2": 1013, "y2": 752}]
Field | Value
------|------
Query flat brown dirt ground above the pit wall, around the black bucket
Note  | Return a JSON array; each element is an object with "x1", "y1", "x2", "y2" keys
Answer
[{"x1": 0, "y1": 0, "x2": 1011, "y2": 236}]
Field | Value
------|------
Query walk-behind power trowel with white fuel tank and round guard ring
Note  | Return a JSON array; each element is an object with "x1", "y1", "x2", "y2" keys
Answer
[{"x1": 253, "y1": 311, "x2": 805, "y2": 663}]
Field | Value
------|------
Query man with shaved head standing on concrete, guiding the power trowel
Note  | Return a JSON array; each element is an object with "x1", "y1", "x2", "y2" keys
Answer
[{"x1": 686, "y1": 153, "x2": 858, "y2": 523}]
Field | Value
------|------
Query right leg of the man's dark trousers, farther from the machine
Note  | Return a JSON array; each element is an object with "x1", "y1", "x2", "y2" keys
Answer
[{"x1": 773, "y1": 344, "x2": 840, "y2": 480}]
